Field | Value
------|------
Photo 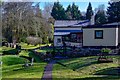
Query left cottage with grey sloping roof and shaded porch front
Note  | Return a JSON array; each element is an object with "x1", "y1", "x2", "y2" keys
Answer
[{"x1": 54, "y1": 20, "x2": 90, "y2": 47}]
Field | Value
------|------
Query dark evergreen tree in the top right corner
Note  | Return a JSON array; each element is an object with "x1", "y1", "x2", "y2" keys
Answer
[{"x1": 107, "y1": 1, "x2": 120, "y2": 22}]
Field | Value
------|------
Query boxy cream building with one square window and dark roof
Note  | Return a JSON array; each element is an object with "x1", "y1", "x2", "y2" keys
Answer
[{"x1": 83, "y1": 22, "x2": 120, "y2": 48}]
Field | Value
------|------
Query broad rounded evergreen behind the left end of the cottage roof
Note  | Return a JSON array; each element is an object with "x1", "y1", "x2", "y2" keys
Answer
[{"x1": 51, "y1": 2, "x2": 66, "y2": 20}]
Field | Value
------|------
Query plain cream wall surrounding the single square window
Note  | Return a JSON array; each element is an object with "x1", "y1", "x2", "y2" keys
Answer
[{"x1": 83, "y1": 28, "x2": 118, "y2": 46}]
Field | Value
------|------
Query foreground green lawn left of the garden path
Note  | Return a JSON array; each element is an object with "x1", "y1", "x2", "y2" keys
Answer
[{"x1": 2, "y1": 55, "x2": 46, "y2": 79}]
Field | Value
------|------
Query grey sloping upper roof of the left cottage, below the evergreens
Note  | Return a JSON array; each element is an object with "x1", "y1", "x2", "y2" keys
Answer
[{"x1": 54, "y1": 20, "x2": 90, "y2": 27}]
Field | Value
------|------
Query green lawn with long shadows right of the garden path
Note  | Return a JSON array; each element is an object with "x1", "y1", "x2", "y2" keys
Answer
[{"x1": 53, "y1": 56, "x2": 120, "y2": 80}]
